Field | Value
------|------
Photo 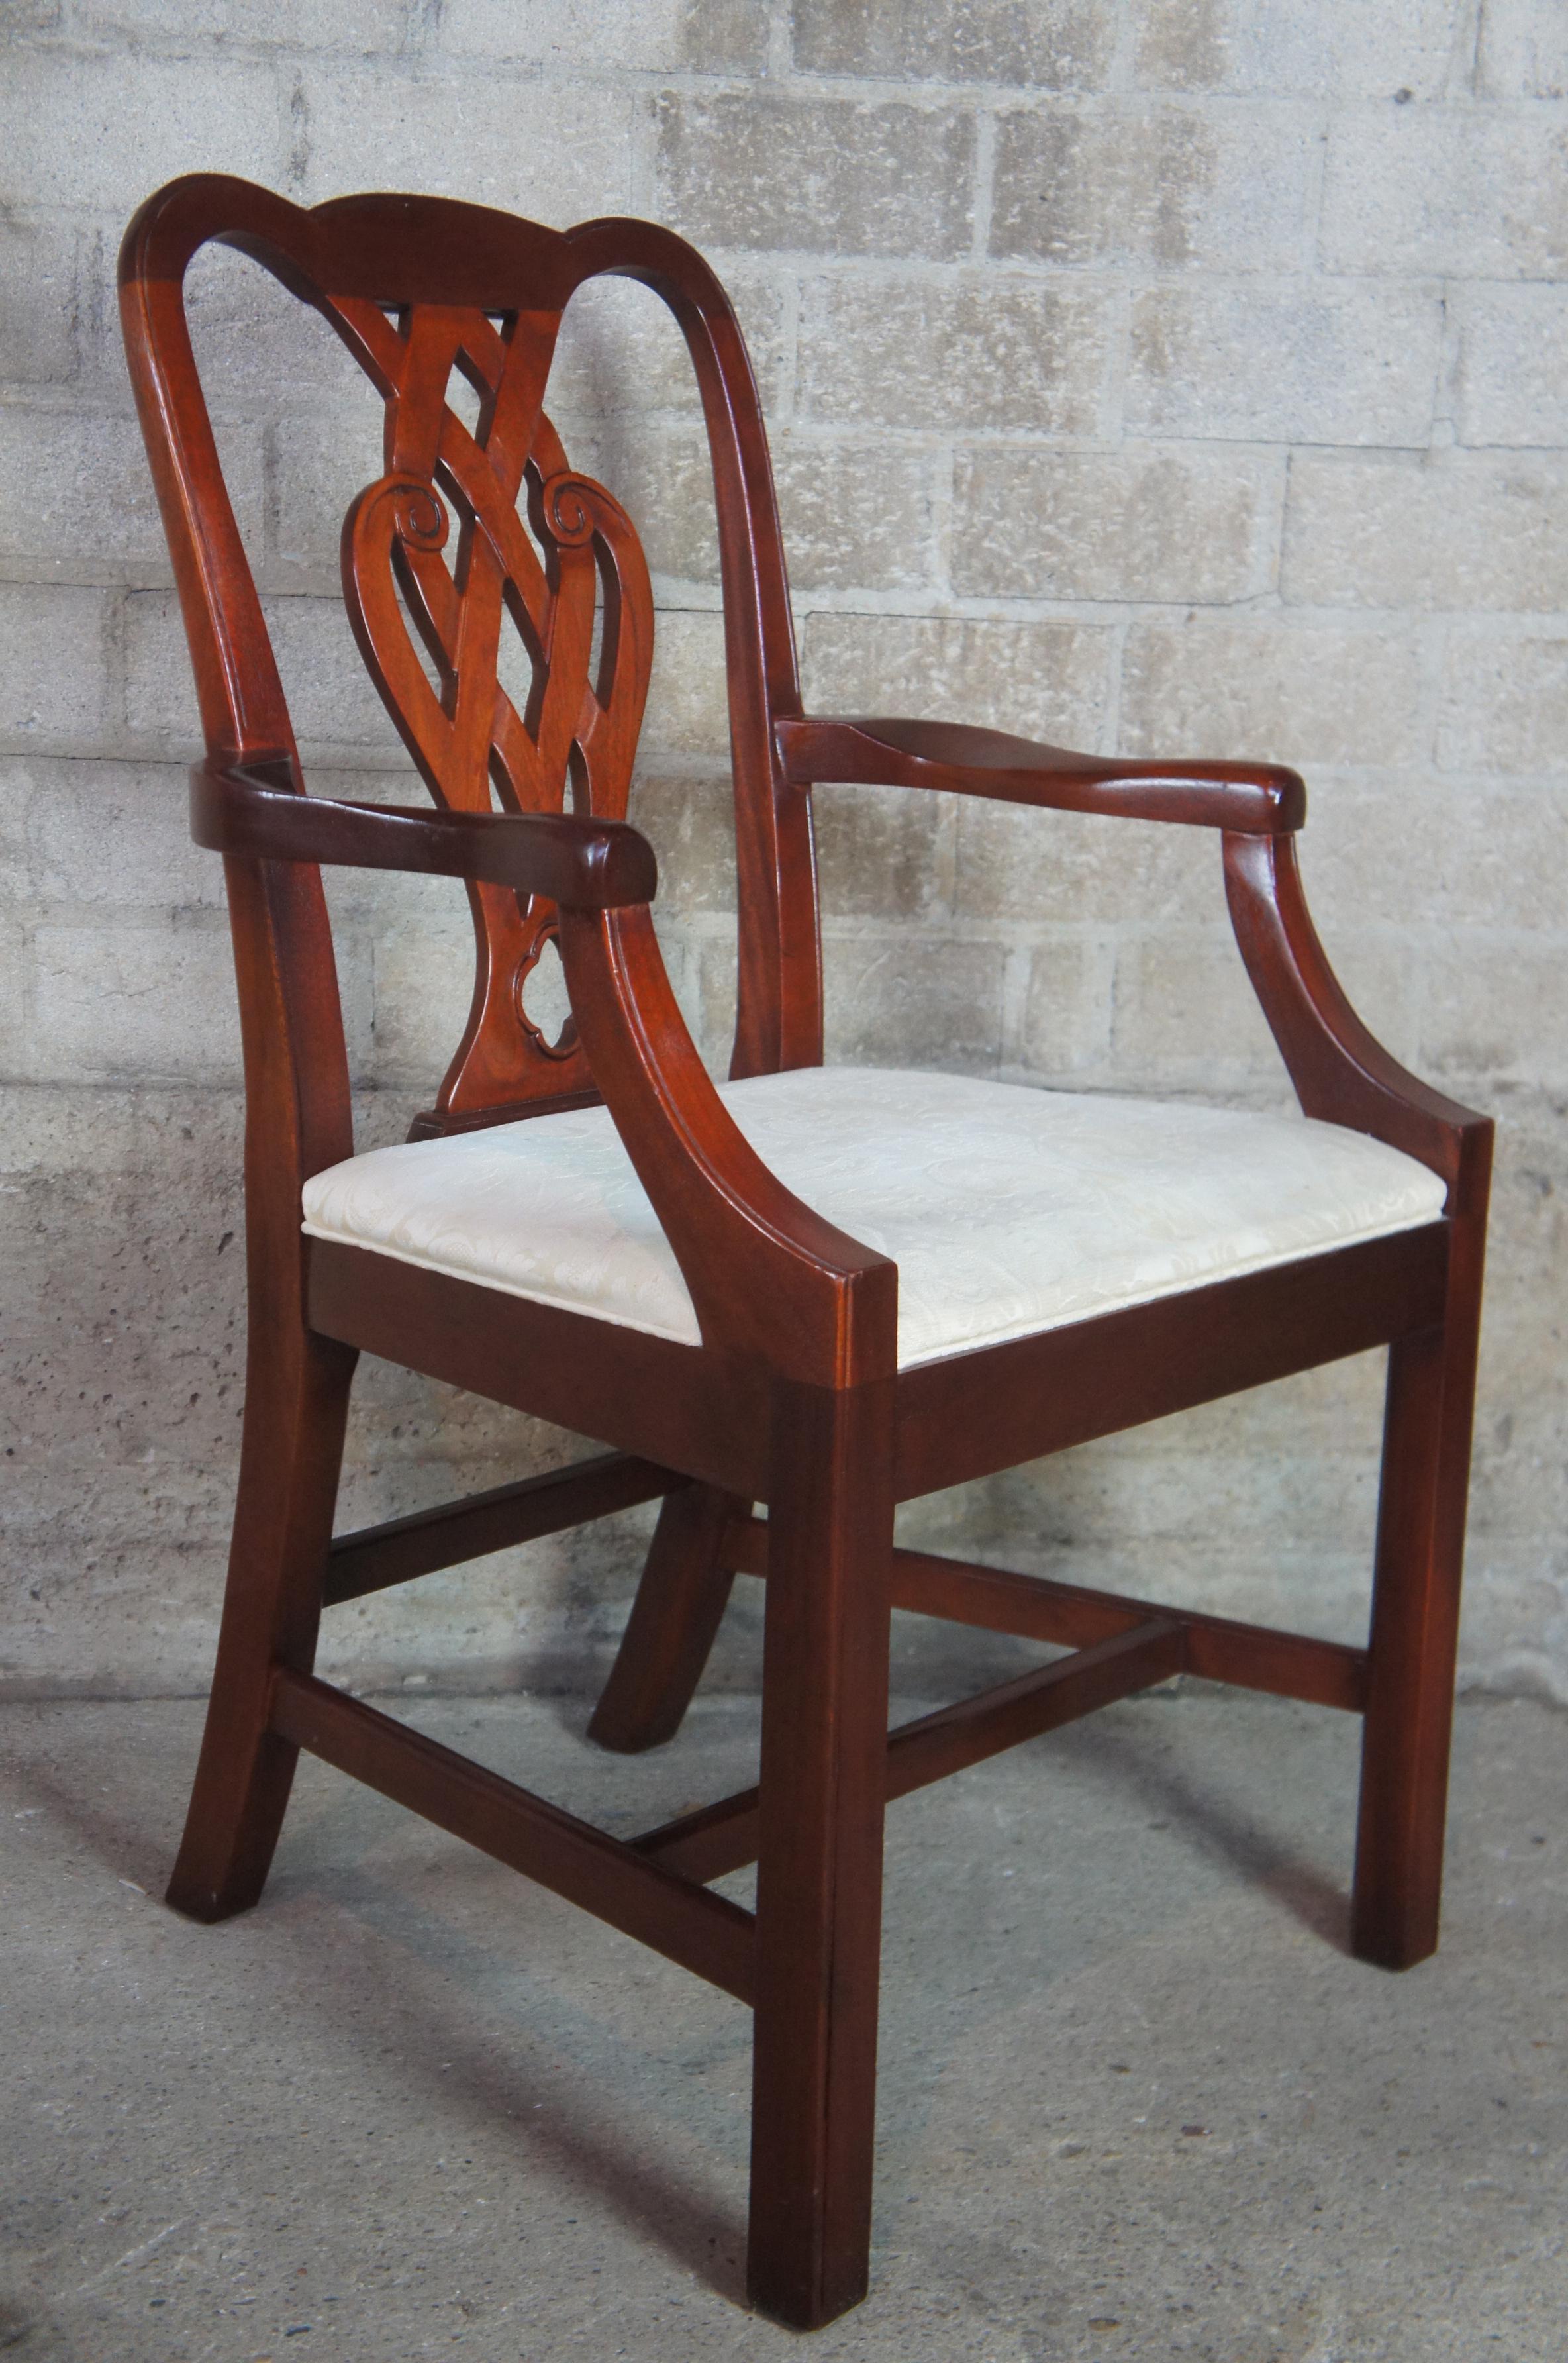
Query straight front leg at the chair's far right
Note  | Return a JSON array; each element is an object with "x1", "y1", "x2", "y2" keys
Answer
[{"x1": 1351, "y1": 1302, "x2": 1476, "y2": 1968}]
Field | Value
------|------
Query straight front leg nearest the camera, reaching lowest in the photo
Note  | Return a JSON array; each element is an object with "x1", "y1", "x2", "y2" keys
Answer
[{"x1": 746, "y1": 1380, "x2": 893, "y2": 2330}]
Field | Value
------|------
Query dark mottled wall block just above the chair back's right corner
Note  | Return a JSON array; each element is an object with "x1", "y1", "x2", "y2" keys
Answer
[{"x1": 652, "y1": 92, "x2": 975, "y2": 258}]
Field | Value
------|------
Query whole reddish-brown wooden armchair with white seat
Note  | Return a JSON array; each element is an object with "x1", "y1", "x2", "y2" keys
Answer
[{"x1": 121, "y1": 175, "x2": 1493, "y2": 2327}]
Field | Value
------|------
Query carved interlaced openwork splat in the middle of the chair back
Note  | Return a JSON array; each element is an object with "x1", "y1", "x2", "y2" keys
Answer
[{"x1": 333, "y1": 300, "x2": 654, "y2": 1132}]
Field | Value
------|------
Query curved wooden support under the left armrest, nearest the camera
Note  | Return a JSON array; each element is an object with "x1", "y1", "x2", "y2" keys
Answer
[{"x1": 560, "y1": 905, "x2": 897, "y2": 1387}]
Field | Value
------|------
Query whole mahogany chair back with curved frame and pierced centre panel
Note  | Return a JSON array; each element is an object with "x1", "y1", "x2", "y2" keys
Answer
[{"x1": 121, "y1": 172, "x2": 822, "y2": 1132}]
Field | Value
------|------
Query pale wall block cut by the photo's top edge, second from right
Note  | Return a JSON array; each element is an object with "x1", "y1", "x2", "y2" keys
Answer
[{"x1": 1131, "y1": 0, "x2": 1469, "y2": 101}]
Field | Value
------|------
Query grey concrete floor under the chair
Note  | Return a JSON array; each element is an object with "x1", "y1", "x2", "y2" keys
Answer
[{"x1": 0, "y1": 1689, "x2": 1568, "y2": 2363}]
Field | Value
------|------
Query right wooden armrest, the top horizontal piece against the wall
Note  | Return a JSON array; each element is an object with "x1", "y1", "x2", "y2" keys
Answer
[{"x1": 775, "y1": 714, "x2": 1306, "y2": 836}]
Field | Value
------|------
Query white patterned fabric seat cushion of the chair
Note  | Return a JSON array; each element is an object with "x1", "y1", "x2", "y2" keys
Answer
[{"x1": 305, "y1": 1066, "x2": 1443, "y2": 1368}]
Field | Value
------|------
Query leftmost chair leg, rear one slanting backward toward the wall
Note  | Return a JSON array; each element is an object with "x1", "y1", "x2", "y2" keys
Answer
[{"x1": 168, "y1": 1323, "x2": 359, "y2": 1921}]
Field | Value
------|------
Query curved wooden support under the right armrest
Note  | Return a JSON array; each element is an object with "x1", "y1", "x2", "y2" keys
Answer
[{"x1": 1223, "y1": 829, "x2": 1493, "y2": 1215}]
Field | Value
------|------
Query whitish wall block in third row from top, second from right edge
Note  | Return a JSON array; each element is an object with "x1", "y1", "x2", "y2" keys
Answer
[{"x1": 1126, "y1": 279, "x2": 1443, "y2": 444}]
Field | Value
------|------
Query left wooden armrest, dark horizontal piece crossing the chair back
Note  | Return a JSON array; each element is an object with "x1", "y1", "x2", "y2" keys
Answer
[{"x1": 191, "y1": 756, "x2": 659, "y2": 910}]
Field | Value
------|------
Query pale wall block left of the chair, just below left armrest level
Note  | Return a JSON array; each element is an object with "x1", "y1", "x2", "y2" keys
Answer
[{"x1": 30, "y1": 915, "x2": 238, "y2": 1089}]
